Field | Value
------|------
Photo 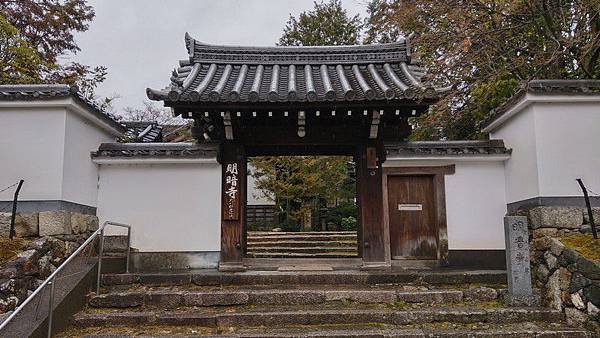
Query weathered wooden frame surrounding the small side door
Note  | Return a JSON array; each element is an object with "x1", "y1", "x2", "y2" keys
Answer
[{"x1": 382, "y1": 165, "x2": 456, "y2": 266}]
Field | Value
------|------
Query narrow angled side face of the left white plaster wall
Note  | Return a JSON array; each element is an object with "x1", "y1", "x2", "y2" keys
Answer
[{"x1": 62, "y1": 112, "x2": 116, "y2": 206}]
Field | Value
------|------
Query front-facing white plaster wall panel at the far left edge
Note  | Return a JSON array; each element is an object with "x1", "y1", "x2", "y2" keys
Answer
[{"x1": 0, "y1": 107, "x2": 66, "y2": 201}]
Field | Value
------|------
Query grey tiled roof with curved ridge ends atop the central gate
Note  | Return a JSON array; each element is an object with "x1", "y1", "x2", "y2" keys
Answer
[{"x1": 147, "y1": 34, "x2": 438, "y2": 103}]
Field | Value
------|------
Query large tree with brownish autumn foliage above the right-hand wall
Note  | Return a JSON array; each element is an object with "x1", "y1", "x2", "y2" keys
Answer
[{"x1": 366, "y1": 0, "x2": 600, "y2": 139}]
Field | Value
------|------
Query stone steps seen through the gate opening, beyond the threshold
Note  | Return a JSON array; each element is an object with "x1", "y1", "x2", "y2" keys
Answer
[{"x1": 246, "y1": 231, "x2": 358, "y2": 258}]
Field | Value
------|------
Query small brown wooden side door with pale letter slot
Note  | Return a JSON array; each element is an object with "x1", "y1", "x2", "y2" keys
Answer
[{"x1": 387, "y1": 175, "x2": 438, "y2": 259}]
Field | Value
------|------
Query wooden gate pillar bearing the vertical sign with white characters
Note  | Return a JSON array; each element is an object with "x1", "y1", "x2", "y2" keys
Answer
[{"x1": 219, "y1": 142, "x2": 247, "y2": 271}]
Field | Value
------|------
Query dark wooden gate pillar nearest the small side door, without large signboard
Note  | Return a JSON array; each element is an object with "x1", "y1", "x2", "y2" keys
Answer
[{"x1": 356, "y1": 143, "x2": 390, "y2": 269}]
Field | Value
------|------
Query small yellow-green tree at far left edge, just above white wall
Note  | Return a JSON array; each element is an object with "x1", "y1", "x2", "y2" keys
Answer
[{"x1": 0, "y1": 15, "x2": 43, "y2": 83}]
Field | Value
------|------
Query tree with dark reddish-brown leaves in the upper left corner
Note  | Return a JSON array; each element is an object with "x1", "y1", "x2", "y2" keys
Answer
[{"x1": 0, "y1": 0, "x2": 107, "y2": 105}]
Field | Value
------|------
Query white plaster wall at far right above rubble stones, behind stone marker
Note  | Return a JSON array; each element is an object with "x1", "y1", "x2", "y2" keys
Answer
[{"x1": 490, "y1": 97, "x2": 600, "y2": 203}]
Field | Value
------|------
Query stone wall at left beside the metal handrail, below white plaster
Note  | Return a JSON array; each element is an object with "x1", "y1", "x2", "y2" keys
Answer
[{"x1": 0, "y1": 210, "x2": 98, "y2": 313}]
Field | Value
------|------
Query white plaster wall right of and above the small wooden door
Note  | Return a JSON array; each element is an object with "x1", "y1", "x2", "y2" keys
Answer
[{"x1": 385, "y1": 159, "x2": 506, "y2": 250}]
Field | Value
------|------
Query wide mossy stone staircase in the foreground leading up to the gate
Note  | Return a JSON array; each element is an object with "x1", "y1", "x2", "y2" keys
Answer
[{"x1": 59, "y1": 271, "x2": 592, "y2": 337}]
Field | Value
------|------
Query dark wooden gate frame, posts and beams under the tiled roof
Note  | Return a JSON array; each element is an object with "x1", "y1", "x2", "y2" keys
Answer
[{"x1": 216, "y1": 105, "x2": 432, "y2": 271}]
